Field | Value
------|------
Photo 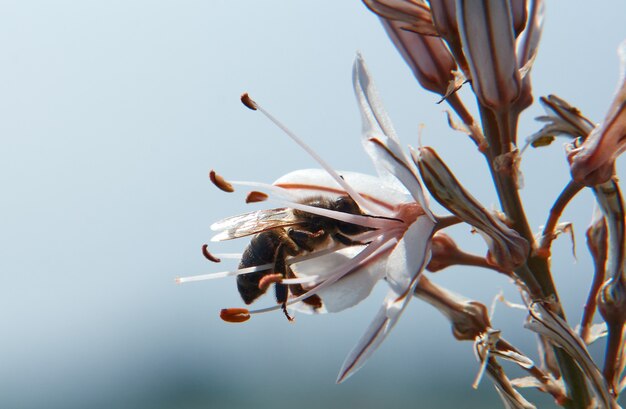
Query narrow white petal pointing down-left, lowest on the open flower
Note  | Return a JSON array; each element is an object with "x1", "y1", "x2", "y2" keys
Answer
[{"x1": 337, "y1": 281, "x2": 417, "y2": 383}]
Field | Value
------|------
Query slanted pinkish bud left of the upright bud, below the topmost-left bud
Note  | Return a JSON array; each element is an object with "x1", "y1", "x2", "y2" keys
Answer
[{"x1": 381, "y1": 18, "x2": 456, "y2": 95}]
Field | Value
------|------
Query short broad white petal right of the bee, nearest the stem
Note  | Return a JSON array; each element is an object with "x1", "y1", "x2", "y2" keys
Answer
[{"x1": 386, "y1": 217, "x2": 435, "y2": 294}]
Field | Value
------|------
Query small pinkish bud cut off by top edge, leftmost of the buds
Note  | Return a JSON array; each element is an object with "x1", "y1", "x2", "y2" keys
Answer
[{"x1": 363, "y1": 0, "x2": 437, "y2": 35}]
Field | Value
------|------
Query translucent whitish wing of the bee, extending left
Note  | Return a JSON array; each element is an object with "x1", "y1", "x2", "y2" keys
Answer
[{"x1": 211, "y1": 207, "x2": 298, "y2": 241}]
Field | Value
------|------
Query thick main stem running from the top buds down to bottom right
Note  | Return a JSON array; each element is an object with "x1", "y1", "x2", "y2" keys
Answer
[{"x1": 479, "y1": 102, "x2": 590, "y2": 409}]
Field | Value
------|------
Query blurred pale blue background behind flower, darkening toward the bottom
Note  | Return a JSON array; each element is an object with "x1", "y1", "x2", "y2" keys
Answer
[{"x1": 0, "y1": 0, "x2": 626, "y2": 409}]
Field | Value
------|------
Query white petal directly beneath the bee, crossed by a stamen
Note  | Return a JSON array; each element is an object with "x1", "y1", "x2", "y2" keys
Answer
[{"x1": 291, "y1": 246, "x2": 385, "y2": 312}]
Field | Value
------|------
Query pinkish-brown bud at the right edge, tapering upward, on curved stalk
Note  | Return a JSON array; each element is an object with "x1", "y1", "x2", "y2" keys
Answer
[{"x1": 567, "y1": 41, "x2": 626, "y2": 186}]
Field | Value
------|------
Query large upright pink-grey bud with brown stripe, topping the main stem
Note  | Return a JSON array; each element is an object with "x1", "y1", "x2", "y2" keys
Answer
[{"x1": 456, "y1": 0, "x2": 521, "y2": 111}]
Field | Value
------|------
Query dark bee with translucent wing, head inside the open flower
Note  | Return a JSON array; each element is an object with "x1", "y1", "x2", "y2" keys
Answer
[{"x1": 214, "y1": 195, "x2": 371, "y2": 321}]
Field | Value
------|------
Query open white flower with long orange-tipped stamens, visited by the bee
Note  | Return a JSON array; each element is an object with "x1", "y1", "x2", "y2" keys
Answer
[{"x1": 178, "y1": 56, "x2": 436, "y2": 382}]
